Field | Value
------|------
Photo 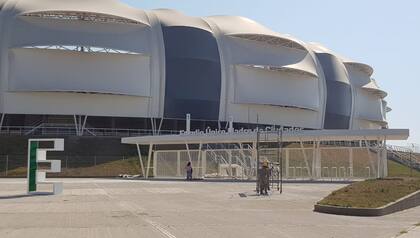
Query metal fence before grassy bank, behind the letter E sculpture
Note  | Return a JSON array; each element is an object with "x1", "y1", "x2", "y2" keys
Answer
[{"x1": 0, "y1": 155, "x2": 141, "y2": 177}]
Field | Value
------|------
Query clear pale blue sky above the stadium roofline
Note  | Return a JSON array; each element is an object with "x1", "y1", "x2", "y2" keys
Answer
[{"x1": 123, "y1": 0, "x2": 420, "y2": 144}]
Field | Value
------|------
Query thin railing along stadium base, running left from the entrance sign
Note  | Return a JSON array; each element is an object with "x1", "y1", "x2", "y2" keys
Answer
[{"x1": 0, "y1": 126, "x2": 179, "y2": 137}]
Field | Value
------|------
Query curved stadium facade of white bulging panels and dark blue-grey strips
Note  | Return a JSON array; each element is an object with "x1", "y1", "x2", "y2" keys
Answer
[{"x1": 0, "y1": 0, "x2": 390, "y2": 134}]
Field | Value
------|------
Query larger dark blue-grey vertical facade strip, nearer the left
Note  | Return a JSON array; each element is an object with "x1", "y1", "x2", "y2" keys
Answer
[{"x1": 162, "y1": 24, "x2": 221, "y2": 121}]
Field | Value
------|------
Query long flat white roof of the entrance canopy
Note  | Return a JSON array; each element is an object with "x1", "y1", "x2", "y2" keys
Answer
[{"x1": 121, "y1": 129, "x2": 409, "y2": 145}]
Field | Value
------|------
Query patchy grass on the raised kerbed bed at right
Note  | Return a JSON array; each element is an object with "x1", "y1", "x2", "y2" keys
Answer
[{"x1": 318, "y1": 178, "x2": 420, "y2": 208}]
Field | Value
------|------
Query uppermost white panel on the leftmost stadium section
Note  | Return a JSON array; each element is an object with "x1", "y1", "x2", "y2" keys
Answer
[{"x1": 10, "y1": 17, "x2": 151, "y2": 53}]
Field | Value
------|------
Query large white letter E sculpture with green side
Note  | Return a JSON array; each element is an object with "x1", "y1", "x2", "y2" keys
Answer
[{"x1": 28, "y1": 139, "x2": 64, "y2": 195}]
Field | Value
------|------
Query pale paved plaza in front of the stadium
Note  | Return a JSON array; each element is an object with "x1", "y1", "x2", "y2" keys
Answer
[{"x1": 0, "y1": 179, "x2": 420, "y2": 238}]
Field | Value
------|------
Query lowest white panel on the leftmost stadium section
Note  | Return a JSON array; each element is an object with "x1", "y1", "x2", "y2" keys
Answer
[{"x1": 4, "y1": 92, "x2": 150, "y2": 117}]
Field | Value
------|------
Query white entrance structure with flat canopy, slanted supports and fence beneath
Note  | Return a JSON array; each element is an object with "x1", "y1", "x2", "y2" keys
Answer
[{"x1": 122, "y1": 129, "x2": 409, "y2": 180}]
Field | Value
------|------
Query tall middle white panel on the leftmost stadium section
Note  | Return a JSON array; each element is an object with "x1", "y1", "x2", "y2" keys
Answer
[{"x1": 9, "y1": 49, "x2": 150, "y2": 97}]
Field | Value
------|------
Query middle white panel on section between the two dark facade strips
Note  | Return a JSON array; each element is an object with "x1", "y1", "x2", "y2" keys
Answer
[{"x1": 234, "y1": 66, "x2": 320, "y2": 110}]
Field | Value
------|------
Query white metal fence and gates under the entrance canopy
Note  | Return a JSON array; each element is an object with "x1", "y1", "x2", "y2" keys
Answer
[{"x1": 151, "y1": 147, "x2": 378, "y2": 181}]
